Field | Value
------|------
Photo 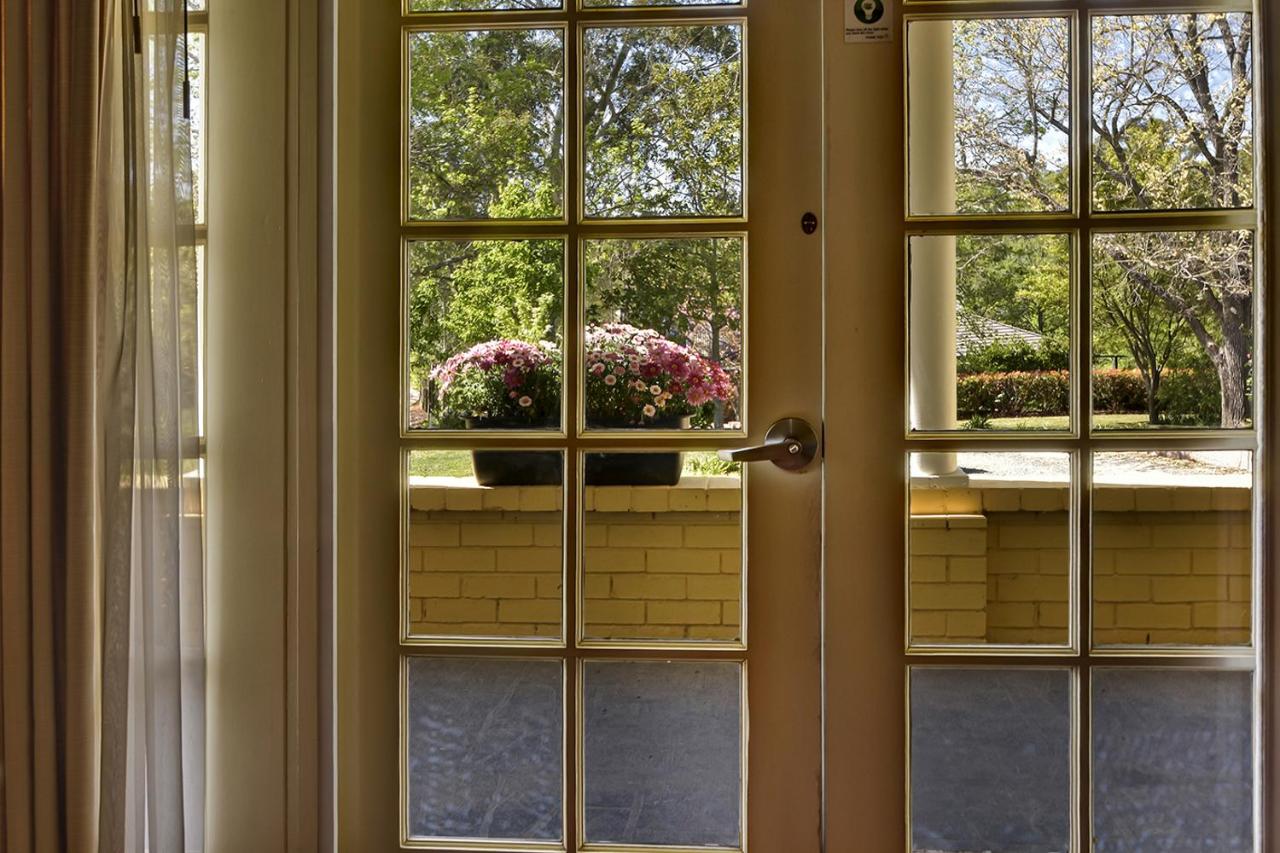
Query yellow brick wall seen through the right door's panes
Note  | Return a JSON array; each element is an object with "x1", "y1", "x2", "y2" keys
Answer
[{"x1": 910, "y1": 487, "x2": 1251, "y2": 644}]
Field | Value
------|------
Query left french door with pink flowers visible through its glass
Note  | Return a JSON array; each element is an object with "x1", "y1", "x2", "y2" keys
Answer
[{"x1": 335, "y1": 0, "x2": 823, "y2": 850}]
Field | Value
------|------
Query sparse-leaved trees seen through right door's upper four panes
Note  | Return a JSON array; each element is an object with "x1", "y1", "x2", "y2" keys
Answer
[{"x1": 954, "y1": 13, "x2": 1253, "y2": 428}]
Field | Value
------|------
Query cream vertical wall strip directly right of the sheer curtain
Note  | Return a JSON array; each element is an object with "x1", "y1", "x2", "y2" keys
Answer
[{"x1": 206, "y1": 0, "x2": 288, "y2": 853}]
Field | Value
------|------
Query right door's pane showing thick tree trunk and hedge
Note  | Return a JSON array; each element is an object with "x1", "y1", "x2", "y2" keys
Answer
[{"x1": 1093, "y1": 231, "x2": 1253, "y2": 429}]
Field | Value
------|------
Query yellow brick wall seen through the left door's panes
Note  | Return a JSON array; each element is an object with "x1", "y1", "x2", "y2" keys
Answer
[{"x1": 407, "y1": 478, "x2": 742, "y2": 640}]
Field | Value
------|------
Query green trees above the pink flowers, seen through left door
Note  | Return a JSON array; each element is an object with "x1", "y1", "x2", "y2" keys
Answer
[{"x1": 407, "y1": 20, "x2": 742, "y2": 415}]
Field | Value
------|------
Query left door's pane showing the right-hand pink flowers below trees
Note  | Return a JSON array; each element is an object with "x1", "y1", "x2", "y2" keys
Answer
[{"x1": 582, "y1": 237, "x2": 744, "y2": 429}]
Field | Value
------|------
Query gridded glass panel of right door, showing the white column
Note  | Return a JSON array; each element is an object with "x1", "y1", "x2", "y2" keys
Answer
[{"x1": 904, "y1": 8, "x2": 1265, "y2": 853}]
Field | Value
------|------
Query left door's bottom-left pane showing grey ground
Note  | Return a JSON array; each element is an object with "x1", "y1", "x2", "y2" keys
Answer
[{"x1": 406, "y1": 657, "x2": 564, "y2": 841}]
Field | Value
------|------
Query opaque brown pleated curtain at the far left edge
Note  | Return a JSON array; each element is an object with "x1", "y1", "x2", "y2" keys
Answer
[{"x1": 0, "y1": 0, "x2": 105, "y2": 853}]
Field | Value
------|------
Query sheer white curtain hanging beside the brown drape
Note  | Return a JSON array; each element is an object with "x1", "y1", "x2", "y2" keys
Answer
[{"x1": 97, "y1": 0, "x2": 204, "y2": 853}]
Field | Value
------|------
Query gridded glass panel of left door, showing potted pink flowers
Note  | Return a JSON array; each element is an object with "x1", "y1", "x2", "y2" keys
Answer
[{"x1": 399, "y1": 0, "x2": 749, "y2": 850}]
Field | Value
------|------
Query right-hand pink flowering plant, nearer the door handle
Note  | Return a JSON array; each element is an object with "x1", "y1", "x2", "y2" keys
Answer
[{"x1": 585, "y1": 324, "x2": 736, "y2": 427}]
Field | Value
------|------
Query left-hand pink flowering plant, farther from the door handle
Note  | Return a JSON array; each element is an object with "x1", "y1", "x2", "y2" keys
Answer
[{"x1": 431, "y1": 341, "x2": 561, "y2": 428}]
